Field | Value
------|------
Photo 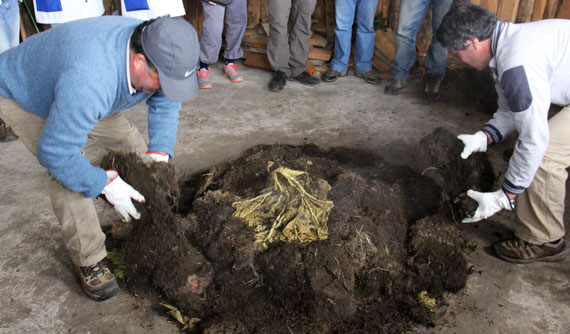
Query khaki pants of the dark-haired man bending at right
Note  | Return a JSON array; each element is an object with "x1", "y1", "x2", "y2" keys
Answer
[{"x1": 515, "y1": 107, "x2": 570, "y2": 244}]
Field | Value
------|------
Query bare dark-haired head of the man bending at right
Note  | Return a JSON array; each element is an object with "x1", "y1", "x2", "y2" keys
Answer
[{"x1": 436, "y1": 4, "x2": 497, "y2": 70}]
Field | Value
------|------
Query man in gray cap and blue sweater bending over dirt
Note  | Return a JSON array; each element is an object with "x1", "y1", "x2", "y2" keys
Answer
[{"x1": 0, "y1": 16, "x2": 200, "y2": 300}]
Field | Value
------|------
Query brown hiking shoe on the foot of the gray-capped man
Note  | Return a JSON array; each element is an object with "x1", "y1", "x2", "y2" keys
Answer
[{"x1": 73, "y1": 261, "x2": 120, "y2": 301}]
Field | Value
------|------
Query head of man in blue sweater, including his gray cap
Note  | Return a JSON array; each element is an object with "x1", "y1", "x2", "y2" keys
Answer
[{"x1": 130, "y1": 16, "x2": 200, "y2": 102}]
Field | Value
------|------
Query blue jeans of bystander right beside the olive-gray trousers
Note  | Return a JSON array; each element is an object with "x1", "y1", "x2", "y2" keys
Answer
[{"x1": 331, "y1": 0, "x2": 378, "y2": 73}]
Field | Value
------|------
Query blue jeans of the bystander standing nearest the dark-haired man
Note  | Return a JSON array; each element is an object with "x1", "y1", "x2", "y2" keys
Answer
[{"x1": 392, "y1": 0, "x2": 453, "y2": 81}]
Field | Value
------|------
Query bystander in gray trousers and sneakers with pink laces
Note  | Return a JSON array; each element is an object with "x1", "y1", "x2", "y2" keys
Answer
[{"x1": 198, "y1": 0, "x2": 247, "y2": 89}]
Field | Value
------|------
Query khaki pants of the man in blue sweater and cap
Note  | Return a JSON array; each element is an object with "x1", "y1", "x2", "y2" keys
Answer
[{"x1": 0, "y1": 96, "x2": 146, "y2": 266}]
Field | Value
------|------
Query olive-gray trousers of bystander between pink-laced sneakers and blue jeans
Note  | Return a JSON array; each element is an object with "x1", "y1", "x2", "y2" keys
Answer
[{"x1": 267, "y1": 0, "x2": 317, "y2": 77}]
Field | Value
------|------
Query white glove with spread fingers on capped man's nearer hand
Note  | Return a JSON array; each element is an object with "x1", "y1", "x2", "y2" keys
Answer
[{"x1": 101, "y1": 169, "x2": 144, "y2": 222}]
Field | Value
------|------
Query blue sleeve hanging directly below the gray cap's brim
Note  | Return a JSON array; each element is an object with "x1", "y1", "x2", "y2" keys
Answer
[{"x1": 147, "y1": 91, "x2": 182, "y2": 158}]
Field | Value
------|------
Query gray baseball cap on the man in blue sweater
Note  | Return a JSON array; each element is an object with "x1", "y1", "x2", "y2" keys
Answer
[{"x1": 141, "y1": 16, "x2": 200, "y2": 102}]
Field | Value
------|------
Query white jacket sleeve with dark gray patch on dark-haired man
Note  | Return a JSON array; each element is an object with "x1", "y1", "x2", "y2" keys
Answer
[{"x1": 485, "y1": 62, "x2": 550, "y2": 194}]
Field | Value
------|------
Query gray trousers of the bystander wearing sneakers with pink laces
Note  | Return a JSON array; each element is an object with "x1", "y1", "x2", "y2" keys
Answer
[{"x1": 200, "y1": 0, "x2": 247, "y2": 64}]
